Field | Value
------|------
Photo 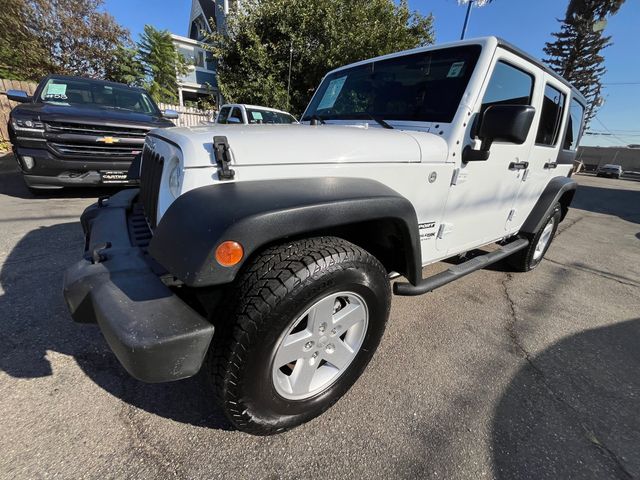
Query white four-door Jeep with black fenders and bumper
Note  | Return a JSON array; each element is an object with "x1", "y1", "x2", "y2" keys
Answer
[{"x1": 64, "y1": 37, "x2": 585, "y2": 435}]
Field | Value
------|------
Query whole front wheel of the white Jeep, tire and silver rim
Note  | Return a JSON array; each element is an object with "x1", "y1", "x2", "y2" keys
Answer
[{"x1": 208, "y1": 237, "x2": 391, "y2": 435}]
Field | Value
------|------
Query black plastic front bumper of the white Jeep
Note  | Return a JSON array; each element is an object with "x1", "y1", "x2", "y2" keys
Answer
[{"x1": 64, "y1": 189, "x2": 213, "y2": 382}]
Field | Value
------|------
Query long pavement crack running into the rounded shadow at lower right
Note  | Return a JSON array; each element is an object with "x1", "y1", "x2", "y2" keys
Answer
[{"x1": 501, "y1": 274, "x2": 635, "y2": 479}]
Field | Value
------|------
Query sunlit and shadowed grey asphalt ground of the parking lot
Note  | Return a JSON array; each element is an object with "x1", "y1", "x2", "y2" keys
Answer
[{"x1": 0, "y1": 156, "x2": 640, "y2": 480}]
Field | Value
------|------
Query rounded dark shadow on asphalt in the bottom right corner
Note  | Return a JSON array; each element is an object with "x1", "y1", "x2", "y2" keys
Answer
[{"x1": 492, "y1": 318, "x2": 640, "y2": 480}]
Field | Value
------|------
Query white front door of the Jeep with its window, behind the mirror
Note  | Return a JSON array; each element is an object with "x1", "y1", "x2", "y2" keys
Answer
[{"x1": 436, "y1": 51, "x2": 535, "y2": 255}]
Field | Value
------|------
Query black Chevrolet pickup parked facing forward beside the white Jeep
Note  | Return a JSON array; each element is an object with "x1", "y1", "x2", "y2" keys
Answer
[{"x1": 7, "y1": 75, "x2": 178, "y2": 189}]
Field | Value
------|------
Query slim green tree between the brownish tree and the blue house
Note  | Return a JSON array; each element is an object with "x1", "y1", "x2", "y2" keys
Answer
[{"x1": 138, "y1": 25, "x2": 188, "y2": 103}]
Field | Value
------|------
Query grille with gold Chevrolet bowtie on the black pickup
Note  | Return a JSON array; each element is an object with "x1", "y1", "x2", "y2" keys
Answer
[{"x1": 45, "y1": 122, "x2": 149, "y2": 160}]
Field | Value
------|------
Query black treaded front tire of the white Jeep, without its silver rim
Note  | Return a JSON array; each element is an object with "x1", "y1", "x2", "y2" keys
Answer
[{"x1": 206, "y1": 237, "x2": 391, "y2": 435}]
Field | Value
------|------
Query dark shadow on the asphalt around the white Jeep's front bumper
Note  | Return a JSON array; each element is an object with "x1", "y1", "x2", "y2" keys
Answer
[{"x1": 0, "y1": 222, "x2": 231, "y2": 430}]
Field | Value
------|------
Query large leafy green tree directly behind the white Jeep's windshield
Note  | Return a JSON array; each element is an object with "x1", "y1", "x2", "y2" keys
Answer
[{"x1": 209, "y1": 0, "x2": 434, "y2": 114}]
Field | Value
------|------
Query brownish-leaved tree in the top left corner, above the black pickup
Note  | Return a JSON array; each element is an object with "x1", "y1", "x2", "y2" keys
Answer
[{"x1": 0, "y1": 0, "x2": 129, "y2": 80}]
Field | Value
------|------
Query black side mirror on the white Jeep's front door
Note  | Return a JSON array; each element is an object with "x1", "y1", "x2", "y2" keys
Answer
[{"x1": 462, "y1": 105, "x2": 536, "y2": 163}]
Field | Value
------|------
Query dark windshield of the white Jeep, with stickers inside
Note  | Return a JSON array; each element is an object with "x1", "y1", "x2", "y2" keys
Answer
[{"x1": 302, "y1": 45, "x2": 481, "y2": 123}]
